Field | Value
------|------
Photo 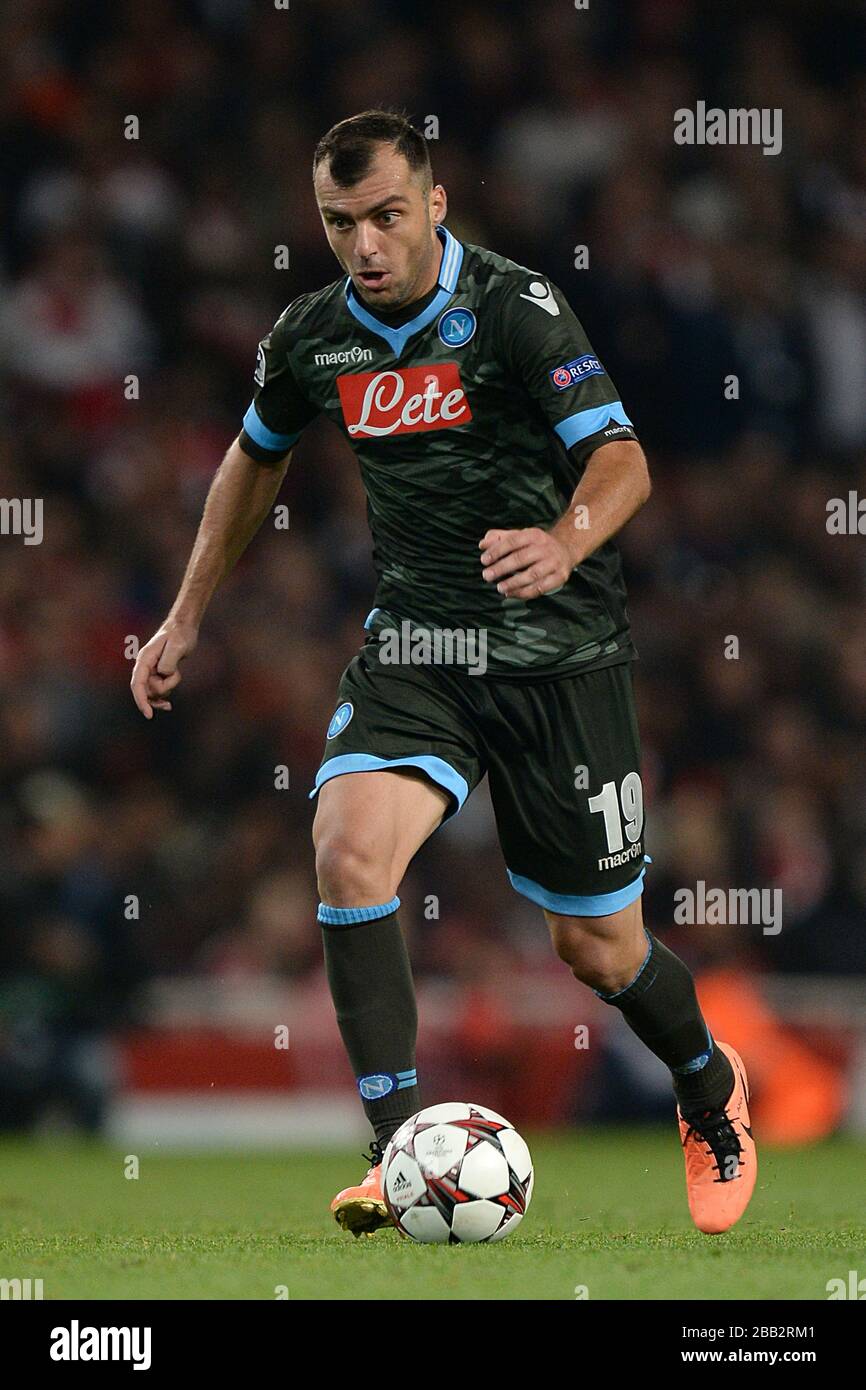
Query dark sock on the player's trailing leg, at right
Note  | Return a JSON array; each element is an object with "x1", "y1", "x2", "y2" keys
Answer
[{"x1": 595, "y1": 929, "x2": 734, "y2": 1116}]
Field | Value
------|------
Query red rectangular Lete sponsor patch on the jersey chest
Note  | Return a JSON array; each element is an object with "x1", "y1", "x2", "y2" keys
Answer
[{"x1": 336, "y1": 361, "x2": 473, "y2": 439}]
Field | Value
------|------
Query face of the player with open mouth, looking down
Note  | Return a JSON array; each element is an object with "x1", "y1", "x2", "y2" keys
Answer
[{"x1": 316, "y1": 145, "x2": 446, "y2": 309}]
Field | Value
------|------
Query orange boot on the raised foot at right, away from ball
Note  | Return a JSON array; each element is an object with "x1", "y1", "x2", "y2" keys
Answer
[{"x1": 677, "y1": 1043, "x2": 758, "y2": 1236}]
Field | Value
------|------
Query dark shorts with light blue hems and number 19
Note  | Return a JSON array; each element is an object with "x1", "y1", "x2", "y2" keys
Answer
[{"x1": 310, "y1": 641, "x2": 645, "y2": 916}]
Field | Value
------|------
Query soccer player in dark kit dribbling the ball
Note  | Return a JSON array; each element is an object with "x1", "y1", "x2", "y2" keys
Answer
[{"x1": 132, "y1": 111, "x2": 756, "y2": 1236}]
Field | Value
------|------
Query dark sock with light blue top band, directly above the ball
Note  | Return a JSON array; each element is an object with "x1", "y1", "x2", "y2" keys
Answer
[{"x1": 318, "y1": 898, "x2": 421, "y2": 1147}]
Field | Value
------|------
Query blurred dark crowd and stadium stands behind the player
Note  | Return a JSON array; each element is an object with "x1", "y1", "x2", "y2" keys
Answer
[{"x1": 0, "y1": 0, "x2": 866, "y2": 1156}]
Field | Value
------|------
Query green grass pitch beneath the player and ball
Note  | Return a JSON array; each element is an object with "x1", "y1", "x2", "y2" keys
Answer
[{"x1": 0, "y1": 1127, "x2": 866, "y2": 1301}]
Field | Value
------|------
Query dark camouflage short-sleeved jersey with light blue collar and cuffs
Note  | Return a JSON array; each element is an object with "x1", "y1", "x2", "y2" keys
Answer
[{"x1": 240, "y1": 228, "x2": 635, "y2": 678}]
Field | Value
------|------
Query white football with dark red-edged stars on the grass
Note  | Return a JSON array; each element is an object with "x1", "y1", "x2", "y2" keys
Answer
[{"x1": 382, "y1": 1101, "x2": 534, "y2": 1245}]
